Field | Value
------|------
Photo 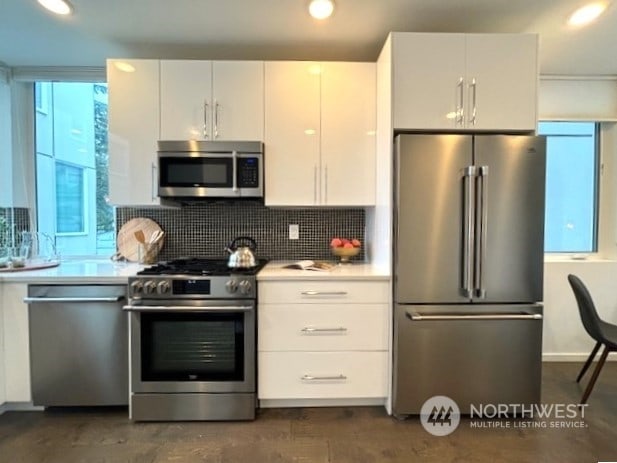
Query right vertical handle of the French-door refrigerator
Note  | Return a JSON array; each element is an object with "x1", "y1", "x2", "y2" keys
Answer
[{"x1": 474, "y1": 166, "x2": 488, "y2": 299}]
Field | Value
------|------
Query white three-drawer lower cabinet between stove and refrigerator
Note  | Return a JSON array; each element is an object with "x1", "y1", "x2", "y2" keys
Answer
[{"x1": 257, "y1": 279, "x2": 390, "y2": 406}]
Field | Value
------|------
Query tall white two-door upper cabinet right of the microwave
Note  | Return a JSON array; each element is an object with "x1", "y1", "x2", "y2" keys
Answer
[{"x1": 265, "y1": 61, "x2": 376, "y2": 206}]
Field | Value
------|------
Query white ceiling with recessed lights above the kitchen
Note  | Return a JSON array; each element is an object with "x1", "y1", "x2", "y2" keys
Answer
[{"x1": 0, "y1": 0, "x2": 617, "y2": 76}]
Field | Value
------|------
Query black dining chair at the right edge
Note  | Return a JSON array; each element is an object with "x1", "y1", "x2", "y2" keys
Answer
[{"x1": 568, "y1": 275, "x2": 617, "y2": 404}]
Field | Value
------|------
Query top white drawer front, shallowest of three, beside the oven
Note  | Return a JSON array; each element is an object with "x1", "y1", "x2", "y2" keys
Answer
[{"x1": 259, "y1": 280, "x2": 390, "y2": 304}]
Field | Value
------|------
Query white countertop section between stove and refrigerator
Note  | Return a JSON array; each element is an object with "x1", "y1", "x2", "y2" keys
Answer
[{"x1": 257, "y1": 260, "x2": 390, "y2": 281}]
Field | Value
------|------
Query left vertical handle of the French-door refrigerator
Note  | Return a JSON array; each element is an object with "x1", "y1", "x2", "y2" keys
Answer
[{"x1": 461, "y1": 166, "x2": 476, "y2": 299}]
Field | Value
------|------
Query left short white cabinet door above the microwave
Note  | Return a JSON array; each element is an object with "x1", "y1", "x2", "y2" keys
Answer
[{"x1": 161, "y1": 60, "x2": 214, "y2": 140}]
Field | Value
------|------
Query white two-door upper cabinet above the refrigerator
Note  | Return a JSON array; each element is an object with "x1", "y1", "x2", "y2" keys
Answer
[{"x1": 392, "y1": 33, "x2": 538, "y2": 132}]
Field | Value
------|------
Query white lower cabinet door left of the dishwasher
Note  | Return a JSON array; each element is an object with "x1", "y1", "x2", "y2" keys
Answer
[{"x1": 2, "y1": 283, "x2": 32, "y2": 402}]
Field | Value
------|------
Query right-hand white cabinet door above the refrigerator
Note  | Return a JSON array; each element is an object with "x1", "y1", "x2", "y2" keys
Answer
[{"x1": 465, "y1": 34, "x2": 538, "y2": 131}]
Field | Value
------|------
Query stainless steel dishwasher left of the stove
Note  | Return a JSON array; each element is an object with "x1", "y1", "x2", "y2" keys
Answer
[{"x1": 24, "y1": 284, "x2": 129, "y2": 406}]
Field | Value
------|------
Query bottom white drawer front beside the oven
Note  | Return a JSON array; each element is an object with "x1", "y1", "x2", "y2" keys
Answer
[{"x1": 257, "y1": 352, "x2": 388, "y2": 399}]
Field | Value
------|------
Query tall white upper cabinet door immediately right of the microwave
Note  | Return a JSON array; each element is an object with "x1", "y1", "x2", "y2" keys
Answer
[{"x1": 265, "y1": 61, "x2": 320, "y2": 206}]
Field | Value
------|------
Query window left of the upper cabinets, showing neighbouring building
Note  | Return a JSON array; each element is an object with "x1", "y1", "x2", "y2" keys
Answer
[{"x1": 33, "y1": 82, "x2": 116, "y2": 256}]
